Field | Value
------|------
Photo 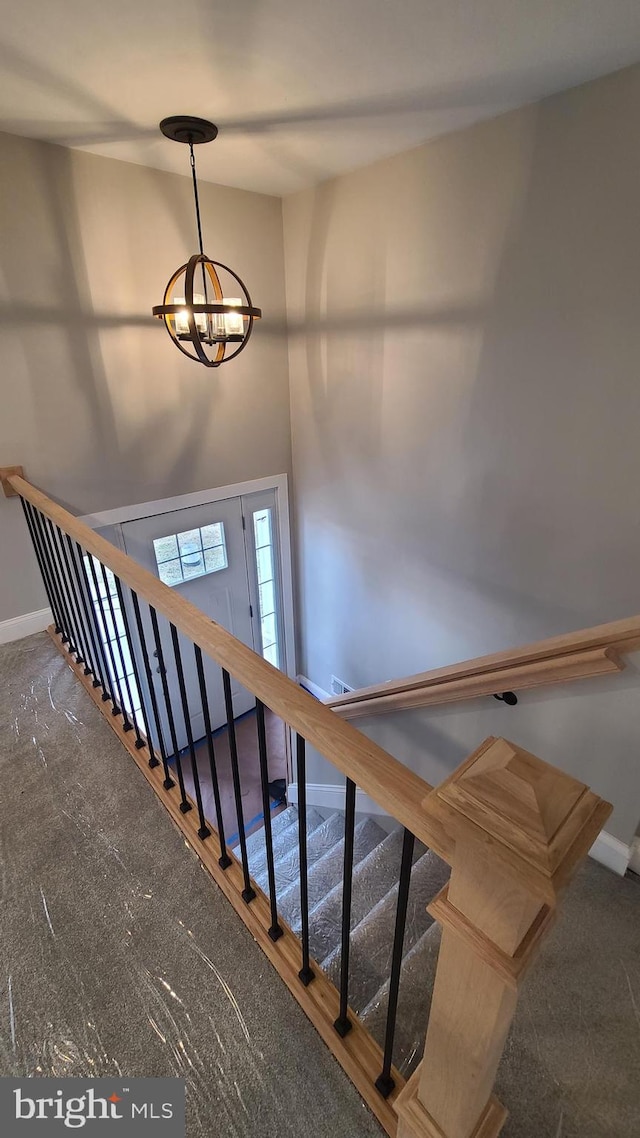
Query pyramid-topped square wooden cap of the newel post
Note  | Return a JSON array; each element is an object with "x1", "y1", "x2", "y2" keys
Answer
[{"x1": 424, "y1": 739, "x2": 612, "y2": 893}]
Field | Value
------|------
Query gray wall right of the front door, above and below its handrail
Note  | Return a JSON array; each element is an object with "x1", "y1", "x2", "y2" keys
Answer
[{"x1": 285, "y1": 68, "x2": 640, "y2": 841}]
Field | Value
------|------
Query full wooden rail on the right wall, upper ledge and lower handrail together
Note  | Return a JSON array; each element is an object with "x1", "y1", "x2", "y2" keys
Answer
[{"x1": 325, "y1": 616, "x2": 640, "y2": 718}]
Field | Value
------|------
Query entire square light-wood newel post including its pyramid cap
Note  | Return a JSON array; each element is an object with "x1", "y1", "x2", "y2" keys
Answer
[{"x1": 395, "y1": 739, "x2": 612, "y2": 1138}]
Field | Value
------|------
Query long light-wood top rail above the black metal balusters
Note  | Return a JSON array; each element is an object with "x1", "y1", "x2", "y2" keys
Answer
[{"x1": 7, "y1": 475, "x2": 453, "y2": 861}]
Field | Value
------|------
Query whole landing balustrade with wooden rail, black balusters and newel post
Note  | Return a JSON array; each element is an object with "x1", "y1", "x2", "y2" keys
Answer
[{"x1": 0, "y1": 468, "x2": 610, "y2": 1138}]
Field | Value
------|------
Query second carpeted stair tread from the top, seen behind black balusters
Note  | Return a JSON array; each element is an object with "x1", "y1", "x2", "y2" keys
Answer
[{"x1": 321, "y1": 850, "x2": 450, "y2": 1013}]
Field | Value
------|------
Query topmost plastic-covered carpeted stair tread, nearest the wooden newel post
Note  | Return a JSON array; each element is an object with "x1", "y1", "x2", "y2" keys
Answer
[{"x1": 360, "y1": 922, "x2": 442, "y2": 1079}]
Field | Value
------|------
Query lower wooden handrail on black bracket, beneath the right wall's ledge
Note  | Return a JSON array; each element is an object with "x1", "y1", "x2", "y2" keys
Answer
[{"x1": 328, "y1": 648, "x2": 624, "y2": 719}]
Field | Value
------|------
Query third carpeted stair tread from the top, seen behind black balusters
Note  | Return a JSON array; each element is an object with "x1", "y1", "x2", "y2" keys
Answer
[{"x1": 310, "y1": 828, "x2": 425, "y2": 960}]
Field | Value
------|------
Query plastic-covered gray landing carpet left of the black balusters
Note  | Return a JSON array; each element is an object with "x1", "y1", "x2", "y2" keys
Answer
[{"x1": 0, "y1": 635, "x2": 381, "y2": 1138}]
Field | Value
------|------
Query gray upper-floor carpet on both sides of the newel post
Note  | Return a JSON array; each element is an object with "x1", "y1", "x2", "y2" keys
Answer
[{"x1": 0, "y1": 636, "x2": 640, "y2": 1138}]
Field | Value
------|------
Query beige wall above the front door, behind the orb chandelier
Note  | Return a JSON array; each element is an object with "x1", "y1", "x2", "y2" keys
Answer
[{"x1": 0, "y1": 134, "x2": 290, "y2": 620}]
